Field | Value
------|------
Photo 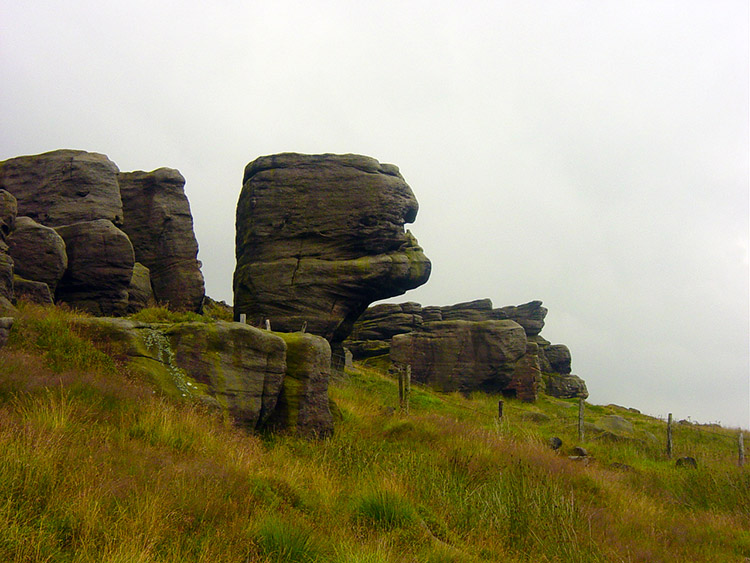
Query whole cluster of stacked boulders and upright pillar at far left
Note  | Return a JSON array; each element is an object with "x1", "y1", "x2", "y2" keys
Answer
[{"x1": 0, "y1": 150, "x2": 203, "y2": 316}]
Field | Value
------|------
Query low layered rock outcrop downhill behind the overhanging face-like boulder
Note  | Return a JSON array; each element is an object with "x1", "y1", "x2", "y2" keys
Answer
[{"x1": 345, "y1": 299, "x2": 588, "y2": 401}]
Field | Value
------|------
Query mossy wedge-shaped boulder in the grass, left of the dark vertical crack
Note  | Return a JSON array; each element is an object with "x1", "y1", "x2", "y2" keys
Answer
[{"x1": 77, "y1": 318, "x2": 288, "y2": 429}]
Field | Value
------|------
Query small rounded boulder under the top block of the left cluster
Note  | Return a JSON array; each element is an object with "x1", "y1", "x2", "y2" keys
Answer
[{"x1": 8, "y1": 217, "x2": 68, "y2": 293}]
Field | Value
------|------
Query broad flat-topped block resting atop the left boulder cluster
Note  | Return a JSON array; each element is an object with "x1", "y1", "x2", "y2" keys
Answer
[{"x1": 0, "y1": 150, "x2": 122, "y2": 227}]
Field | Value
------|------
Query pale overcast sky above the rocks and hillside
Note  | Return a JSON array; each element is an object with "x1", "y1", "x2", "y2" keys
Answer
[{"x1": 0, "y1": 0, "x2": 750, "y2": 428}]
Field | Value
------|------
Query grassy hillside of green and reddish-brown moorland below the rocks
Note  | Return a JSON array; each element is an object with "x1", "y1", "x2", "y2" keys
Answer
[{"x1": 0, "y1": 306, "x2": 750, "y2": 563}]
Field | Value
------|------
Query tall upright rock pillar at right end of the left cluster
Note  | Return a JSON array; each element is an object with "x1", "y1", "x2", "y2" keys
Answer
[{"x1": 118, "y1": 168, "x2": 205, "y2": 312}]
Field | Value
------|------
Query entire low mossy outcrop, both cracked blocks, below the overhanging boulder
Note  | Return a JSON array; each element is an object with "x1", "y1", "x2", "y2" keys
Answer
[{"x1": 72, "y1": 318, "x2": 333, "y2": 436}]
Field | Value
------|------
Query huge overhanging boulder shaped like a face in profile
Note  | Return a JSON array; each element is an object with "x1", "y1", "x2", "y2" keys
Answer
[{"x1": 234, "y1": 153, "x2": 430, "y2": 343}]
